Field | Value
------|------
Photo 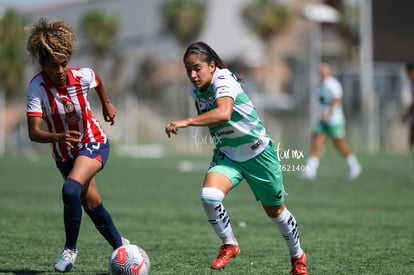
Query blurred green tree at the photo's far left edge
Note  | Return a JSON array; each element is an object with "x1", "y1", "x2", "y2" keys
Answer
[{"x1": 0, "y1": 9, "x2": 27, "y2": 97}]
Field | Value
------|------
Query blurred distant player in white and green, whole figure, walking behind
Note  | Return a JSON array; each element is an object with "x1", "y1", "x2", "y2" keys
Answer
[{"x1": 302, "y1": 64, "x2": 361, "y2": 180}]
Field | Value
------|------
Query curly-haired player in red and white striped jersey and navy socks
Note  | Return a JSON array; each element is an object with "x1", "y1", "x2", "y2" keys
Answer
[{"x1": 27, "y1": 18, "x2": 128, "y2": 272}]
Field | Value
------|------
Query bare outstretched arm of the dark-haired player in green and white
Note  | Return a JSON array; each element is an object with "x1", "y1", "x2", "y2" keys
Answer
[{"x1": 165, "y1": 96, "x2": 234, "y2": 137}]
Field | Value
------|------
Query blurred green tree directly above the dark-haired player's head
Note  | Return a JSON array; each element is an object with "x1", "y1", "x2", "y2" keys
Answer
[{"x1": 161, "y1": 0, "x2": 206, "y2": 46}]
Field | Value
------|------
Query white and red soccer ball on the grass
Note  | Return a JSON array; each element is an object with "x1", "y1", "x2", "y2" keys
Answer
[{"x1": 109, "y1": 244, "x2": 151, "y2": 275}]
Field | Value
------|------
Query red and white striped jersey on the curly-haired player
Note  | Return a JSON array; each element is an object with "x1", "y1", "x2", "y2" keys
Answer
[{"x1": 26, "y1": 68, "x2": 107, "y2": 162}]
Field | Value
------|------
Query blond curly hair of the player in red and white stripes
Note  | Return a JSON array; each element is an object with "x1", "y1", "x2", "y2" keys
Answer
[{"x1": 26, "y1": 17, "x2": 76, "y2": 64}]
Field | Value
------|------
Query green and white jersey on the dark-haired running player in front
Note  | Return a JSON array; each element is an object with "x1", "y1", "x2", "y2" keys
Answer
[{"x1": 191, "y1": 68, "x2": 270, "y2": 161}]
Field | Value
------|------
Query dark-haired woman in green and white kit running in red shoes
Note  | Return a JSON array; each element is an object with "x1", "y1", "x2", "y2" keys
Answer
[{"x1": 165, "y1": 42, "x2": 308, "y2": 275}]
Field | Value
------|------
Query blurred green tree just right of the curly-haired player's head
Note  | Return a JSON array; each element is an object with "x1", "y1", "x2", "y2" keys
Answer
[{"x1": 80, "y1": 9, "x2": 120, "y2": 70}]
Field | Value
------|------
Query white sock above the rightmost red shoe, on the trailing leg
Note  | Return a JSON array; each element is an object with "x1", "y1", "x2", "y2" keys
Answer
[{"x1": 270, "y1": 208, "x2": 302, "y2": 258}]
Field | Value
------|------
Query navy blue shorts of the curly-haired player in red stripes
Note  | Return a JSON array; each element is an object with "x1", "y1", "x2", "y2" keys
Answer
[{"x1": 56, "y1": 141, "x2": 110, "y2": 178}]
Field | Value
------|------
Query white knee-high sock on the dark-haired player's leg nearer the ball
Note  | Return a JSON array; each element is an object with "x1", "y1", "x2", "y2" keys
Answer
[{"x1": 201, "y1": 187, "x2": 237, "y2": 244}]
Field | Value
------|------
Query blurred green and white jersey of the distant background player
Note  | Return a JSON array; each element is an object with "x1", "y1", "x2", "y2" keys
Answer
[{"x1": 318, "y1": 76, "x2": 345, "y2": 124}]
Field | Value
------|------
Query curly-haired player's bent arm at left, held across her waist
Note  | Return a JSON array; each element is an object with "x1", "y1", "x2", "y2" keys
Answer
[{"x1": 27, "y1": 116, "x2": 80, "y2": 148}]
